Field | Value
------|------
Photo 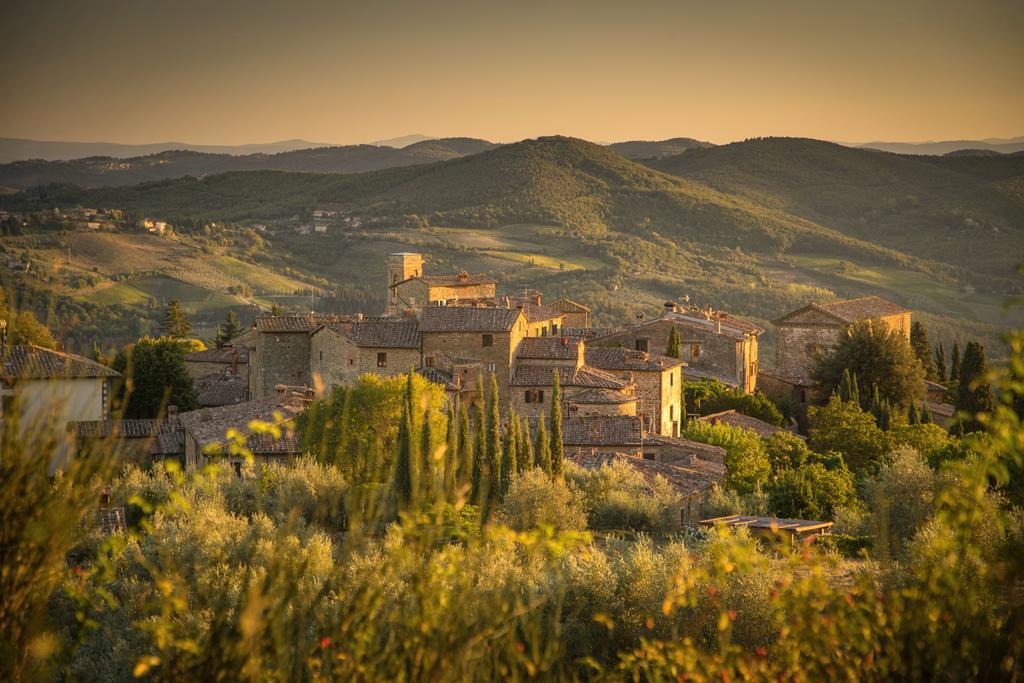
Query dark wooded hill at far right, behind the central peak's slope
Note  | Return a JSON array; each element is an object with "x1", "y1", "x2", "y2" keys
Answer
[{"x1": 650, "y1": 138, "x2": 1024, "y2": 275}]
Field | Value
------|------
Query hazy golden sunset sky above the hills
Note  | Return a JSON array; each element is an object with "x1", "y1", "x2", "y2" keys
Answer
[{"x1": 0, "y1": 0, "x2": 1024, "y2": 144}]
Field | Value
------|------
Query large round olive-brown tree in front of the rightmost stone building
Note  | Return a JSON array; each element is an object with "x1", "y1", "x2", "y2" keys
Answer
[{"x1": 811, "y1": 322, "x2": 925, "y2": 409}]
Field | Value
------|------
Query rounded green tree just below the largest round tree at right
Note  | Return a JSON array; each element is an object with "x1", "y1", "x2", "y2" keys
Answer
[{"x1": 808, "y1": 396, "x2": 889, "y2": 476}]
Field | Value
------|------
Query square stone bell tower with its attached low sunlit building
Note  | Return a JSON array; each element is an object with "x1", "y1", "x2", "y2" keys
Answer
[{"x1": 387, "y1": 252, "x2": 497, "y2": 314}]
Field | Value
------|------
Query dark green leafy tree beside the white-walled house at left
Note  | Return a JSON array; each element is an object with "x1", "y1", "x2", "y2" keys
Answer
[{"x1": 114, "y1": 337, "x2": 203, "y2": 418}]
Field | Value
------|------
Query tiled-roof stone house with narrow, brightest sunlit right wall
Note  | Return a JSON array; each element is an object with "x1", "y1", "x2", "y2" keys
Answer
[{"x1": 585, "y1": 346, "x2": 686, "y2": 436}]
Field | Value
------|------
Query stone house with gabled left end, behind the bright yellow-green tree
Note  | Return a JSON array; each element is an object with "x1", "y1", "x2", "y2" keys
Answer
[{"x1": 309, "y1": 319, "x2": 421, "y2": 391}]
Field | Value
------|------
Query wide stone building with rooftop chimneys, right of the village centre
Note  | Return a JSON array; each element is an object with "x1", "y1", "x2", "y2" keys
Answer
[{"x1": 589, "y1": 301, "x2": 764, "y2": 393}]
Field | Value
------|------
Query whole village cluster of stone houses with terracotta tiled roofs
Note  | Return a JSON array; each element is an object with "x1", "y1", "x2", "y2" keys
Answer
[{"x1": 3, "y1": 253, "x2": 951, "y2": 523}]
